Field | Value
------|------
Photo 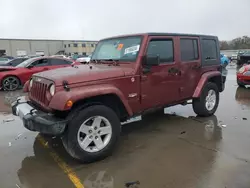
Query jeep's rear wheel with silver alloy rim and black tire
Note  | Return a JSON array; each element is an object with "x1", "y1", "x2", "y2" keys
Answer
[{"x1": 193, "y1": 82, "x2": 219, "y2": 117}]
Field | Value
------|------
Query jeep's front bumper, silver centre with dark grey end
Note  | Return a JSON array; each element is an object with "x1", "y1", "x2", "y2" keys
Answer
[{"x1": 12, "y1": 97, "x2": 68, "y2": 136}]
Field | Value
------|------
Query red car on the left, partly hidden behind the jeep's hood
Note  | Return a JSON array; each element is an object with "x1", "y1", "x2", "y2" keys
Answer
[{"x1": 0, "y1": 56, "x2": 80, "y2": 91}]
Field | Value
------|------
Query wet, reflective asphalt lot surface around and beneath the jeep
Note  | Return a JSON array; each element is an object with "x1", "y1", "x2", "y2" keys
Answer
[{"x1": 0, "y1": 63, "x2": 250, "y2": 188}]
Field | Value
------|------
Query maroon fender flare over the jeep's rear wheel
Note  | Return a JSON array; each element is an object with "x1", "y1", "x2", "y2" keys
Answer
[{"x1": 193, "y1": 71, "x2": 221, "y2": 98}]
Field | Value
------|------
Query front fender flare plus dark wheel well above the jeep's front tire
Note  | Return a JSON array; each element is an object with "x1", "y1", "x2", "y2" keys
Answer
[{"x1": 49, "y1": 85, "x2": 132, "y2": 117}]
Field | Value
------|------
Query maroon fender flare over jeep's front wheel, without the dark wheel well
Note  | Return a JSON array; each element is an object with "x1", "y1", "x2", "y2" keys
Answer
[{"x1": 49, "y1": 85, "x2": 132, "y2": 115}]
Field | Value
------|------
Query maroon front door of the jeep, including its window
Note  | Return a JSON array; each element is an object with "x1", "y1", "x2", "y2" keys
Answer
[{"x1": 141, "y1": 36, "x2": 180, "y2": 109}]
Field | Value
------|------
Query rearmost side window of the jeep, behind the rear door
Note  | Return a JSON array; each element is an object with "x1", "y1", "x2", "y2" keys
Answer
[{"x1": 202, "y1": 39, "x2": 218, "y2": 60}]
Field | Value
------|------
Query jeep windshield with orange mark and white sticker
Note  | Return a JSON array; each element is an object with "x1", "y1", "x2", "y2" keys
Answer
[{"x1": 91, "y1": 36, "x2": 142, "y2": 62}]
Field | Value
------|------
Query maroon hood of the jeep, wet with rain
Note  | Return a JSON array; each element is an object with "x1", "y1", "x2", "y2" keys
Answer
[{"x1": 34, "y1": 64, "x2": 133, "y2": 86}]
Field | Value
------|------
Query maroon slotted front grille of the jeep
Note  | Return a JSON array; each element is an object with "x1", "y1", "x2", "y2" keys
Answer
[{"x1": 30, "y1": 80, "x2": 49, "y2": 106}]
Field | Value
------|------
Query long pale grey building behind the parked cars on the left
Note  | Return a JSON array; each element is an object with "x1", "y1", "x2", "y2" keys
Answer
[{"x1": 0, "y1": 39, "x2": 97, "y2": 57}]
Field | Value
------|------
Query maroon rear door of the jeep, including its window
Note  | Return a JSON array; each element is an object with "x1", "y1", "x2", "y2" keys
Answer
[{"x1": 179, "y1": 37, "x2": 202, "y2": 99}]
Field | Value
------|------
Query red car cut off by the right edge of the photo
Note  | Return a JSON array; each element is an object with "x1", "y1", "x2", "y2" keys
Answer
[{"x1": 237, "y1": 65, "x2": 250, "y2": 87}]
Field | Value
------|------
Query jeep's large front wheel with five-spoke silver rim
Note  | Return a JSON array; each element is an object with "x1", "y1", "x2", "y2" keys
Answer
[{"x1": 62, "y1": 105, "x2": 121, "y2": 163}]
